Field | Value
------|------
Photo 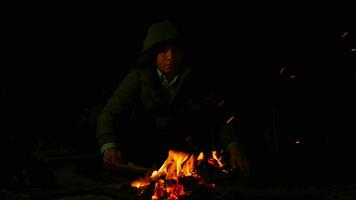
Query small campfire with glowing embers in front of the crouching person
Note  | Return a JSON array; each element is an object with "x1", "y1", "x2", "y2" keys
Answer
[{"x1": 131, "y1": 150, "x2": 228, "y2": 200}]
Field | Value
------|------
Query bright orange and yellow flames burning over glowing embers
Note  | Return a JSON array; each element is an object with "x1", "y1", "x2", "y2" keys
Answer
[{"x1": 131, "y1": 150, "x2": 228, "y2": 200}]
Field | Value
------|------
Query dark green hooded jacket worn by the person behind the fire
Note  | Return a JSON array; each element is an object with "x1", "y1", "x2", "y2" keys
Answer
[{"x1": 97, "y1": 21, "x2": 238, "y2": 157}]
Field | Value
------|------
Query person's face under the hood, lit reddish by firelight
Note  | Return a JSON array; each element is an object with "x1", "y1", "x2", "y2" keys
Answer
[{"x1": 156, "y1": 45, "x2": 183, "y2": 75}]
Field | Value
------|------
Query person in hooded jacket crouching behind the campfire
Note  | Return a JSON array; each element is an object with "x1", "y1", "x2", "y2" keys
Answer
[{"x1": 97, "y1": 20, "x2": 248, "y2": 177}]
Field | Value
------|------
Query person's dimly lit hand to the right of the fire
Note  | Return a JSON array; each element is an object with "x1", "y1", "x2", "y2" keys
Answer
[{"x1": 230, "y1": 145, "x2": 250, "y2": 178}]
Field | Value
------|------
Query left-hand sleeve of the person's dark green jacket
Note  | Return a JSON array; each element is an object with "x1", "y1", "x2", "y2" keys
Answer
[{"x1": 96, "y1": 69, "x2": 139, "y2": 146}]
